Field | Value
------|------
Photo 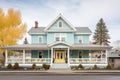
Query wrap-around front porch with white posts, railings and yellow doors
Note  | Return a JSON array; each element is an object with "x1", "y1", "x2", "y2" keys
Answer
[{"x1": 5, "y1": 46, "x2": 109, "y2": 66}]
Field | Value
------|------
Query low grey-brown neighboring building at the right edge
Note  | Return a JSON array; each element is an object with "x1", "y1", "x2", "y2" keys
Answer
[{"x1": 108, "y1": 49, "x2": 120, "y2": 68}]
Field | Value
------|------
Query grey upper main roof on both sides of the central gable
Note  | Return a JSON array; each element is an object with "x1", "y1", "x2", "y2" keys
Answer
[{"x1": 28, "y1": 27, "x2": 92, "y2": 34}]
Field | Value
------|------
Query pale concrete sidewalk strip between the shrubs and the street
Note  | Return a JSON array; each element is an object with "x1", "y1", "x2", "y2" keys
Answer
[{"x1": 0, "y1": 69, "x2": 120, "y2": 74}]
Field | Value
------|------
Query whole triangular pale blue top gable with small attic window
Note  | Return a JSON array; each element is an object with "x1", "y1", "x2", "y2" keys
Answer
[{"x1": 45, "y1": 14, "x2": 76, "y2": 32}]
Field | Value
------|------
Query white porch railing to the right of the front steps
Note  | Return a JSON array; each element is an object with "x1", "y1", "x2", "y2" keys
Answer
[{"x1": 69, "y1": 58, "x2": 106, "y2": 64}]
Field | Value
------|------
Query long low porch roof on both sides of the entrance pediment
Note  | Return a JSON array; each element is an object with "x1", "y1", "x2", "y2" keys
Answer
[{"x1": 1, "y1": 44, "x2": 112, "y2": 50}]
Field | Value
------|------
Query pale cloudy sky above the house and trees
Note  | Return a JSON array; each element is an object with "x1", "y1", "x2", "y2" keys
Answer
[{"x1": 0, "y1": 0, "x2": 120, "y2": 45}]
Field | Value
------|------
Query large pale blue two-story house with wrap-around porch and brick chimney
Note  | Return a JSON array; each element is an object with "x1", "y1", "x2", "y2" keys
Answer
[{"x1": 4, "y1": 14, "x2": 111, "y2": 68}]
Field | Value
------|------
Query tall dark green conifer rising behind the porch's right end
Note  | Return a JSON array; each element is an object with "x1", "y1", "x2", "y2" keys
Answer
[{"x1": 93, "y1": 18, "x2": 110, "y2": 45}]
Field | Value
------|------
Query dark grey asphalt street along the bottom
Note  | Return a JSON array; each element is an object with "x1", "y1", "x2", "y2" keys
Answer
[{"x1": 0, "y1": 74, "x2": 120, "y2": 80}]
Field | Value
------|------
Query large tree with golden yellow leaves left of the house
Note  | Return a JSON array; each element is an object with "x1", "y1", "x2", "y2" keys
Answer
[{"x1": 0, "y1": 8, "x2": 27, "y2": 64}]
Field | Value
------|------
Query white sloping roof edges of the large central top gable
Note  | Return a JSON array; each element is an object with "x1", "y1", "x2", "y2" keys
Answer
[{"x1": 44, "y1": 14, "x2": 76, "y2": 31}]
